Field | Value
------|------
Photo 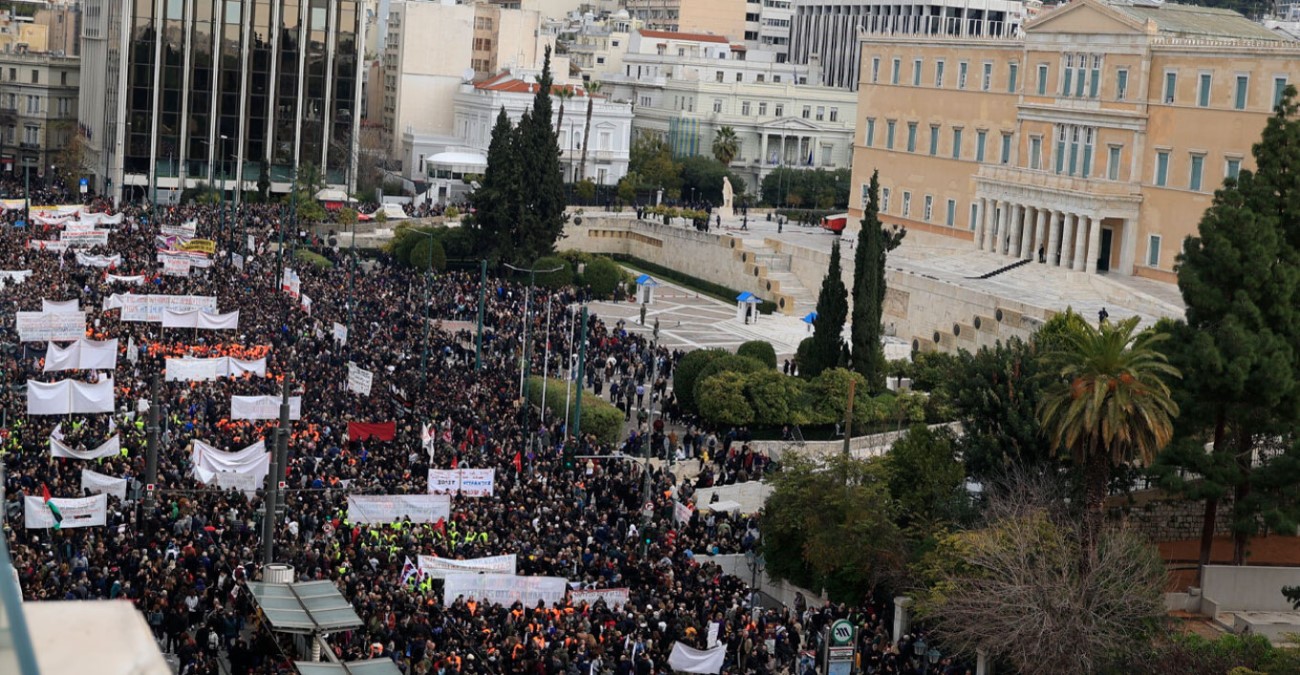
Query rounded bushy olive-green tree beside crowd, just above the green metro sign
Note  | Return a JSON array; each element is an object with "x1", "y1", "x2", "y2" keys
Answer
[{"x1": 763, "y1": 453, "x2": 905, "y2": 602}]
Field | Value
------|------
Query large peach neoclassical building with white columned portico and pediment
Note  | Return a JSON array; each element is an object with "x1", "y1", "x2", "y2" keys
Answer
[{"x1": 852, "y1": 0, "x2": 1300, "y2": 281}]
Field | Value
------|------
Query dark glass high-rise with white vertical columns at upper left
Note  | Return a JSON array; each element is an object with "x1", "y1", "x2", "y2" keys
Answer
[{"x1": 81, "y1": 0, "x2": 365, "y2": 199}]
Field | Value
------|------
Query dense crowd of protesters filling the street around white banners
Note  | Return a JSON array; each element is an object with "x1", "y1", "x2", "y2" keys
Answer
[{"x1": 0, "y1": 187, "x2": 963, "y2": 675}]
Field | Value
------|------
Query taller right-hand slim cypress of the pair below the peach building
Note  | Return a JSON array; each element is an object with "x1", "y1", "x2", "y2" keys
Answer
[{"x1": 852, "y1": 172, "x2": 907, "y2": 393}]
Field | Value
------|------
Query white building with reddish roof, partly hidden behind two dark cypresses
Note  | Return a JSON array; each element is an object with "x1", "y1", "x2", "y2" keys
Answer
[{"x1": 402, "y1": 70, "x2": 632, "y2": 200}]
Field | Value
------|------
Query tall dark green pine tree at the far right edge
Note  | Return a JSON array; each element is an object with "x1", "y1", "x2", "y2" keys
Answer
[{"x1": 1154, "y1": 90, "x2": 1300, "y2": 564}]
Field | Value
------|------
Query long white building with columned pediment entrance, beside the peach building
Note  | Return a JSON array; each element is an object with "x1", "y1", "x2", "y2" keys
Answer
[{"x1": 605, "y1": 31, "x2": 857, "y2": 192}]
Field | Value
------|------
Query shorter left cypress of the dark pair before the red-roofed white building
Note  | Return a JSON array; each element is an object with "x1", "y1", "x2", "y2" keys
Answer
[{"x1": 469, "y1": 108, "x2": 519, "y2": 264}]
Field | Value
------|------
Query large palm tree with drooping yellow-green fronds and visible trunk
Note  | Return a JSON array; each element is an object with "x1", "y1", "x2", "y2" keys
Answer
[{"x1": 1037, "y1": 317, "x2": 1182, "y2": 571}]
